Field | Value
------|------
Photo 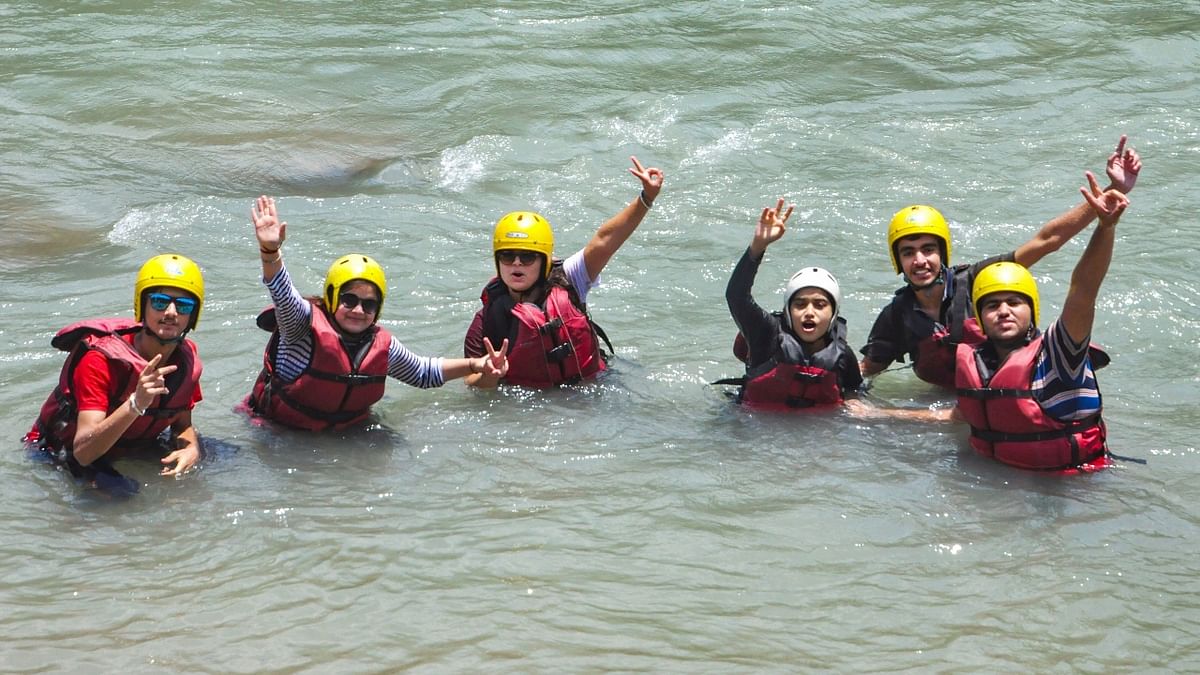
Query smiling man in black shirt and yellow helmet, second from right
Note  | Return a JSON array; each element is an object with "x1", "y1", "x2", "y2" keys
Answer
[{"x1": 862, "y1": 136, "x2": 1141, "y2": 388}]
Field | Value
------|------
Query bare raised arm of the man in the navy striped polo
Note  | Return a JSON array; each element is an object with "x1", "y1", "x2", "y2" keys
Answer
[{"x1": 1060, "y1": 172, "x2": 1129, "y2": 345}]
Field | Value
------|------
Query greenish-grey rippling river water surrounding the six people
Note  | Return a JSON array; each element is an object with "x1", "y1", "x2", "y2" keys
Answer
[{"x1": 0, "y1": 0, "x2": 1200, "y2": 673}]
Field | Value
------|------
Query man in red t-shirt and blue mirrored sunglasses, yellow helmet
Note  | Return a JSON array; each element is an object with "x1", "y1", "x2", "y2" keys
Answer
[{"x1": 24, "y1": 253, "x2": 204, "y2": 494}]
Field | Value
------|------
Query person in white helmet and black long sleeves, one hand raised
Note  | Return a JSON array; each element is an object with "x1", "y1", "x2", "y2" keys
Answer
[{"x1": 721, "y1": 194, "x2": 863, "y2": 408}]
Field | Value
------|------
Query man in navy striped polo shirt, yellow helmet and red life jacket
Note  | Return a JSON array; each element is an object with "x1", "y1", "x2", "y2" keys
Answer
[{"x1": 852, "y1": 172, "x2": 1129, "y2": 473}]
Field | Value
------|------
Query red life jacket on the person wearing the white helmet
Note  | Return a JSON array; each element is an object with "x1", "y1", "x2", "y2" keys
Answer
[{"x1": 733, "y1": 312, "x2": 857, "y2": 410}]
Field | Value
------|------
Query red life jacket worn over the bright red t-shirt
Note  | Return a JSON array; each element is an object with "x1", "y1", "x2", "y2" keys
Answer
[{"x1": 25, "y1": 318, "x2": 204, "y2": 460}]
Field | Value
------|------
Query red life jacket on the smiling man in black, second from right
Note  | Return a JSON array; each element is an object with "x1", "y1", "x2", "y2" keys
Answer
[{"x1": 895, "y1": 265, "x2": 978, "y2": 389}]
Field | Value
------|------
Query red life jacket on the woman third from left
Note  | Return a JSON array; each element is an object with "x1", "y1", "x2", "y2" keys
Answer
[{"x1": 480, "y1": 279, "x2": 606, "y2": 388}]
